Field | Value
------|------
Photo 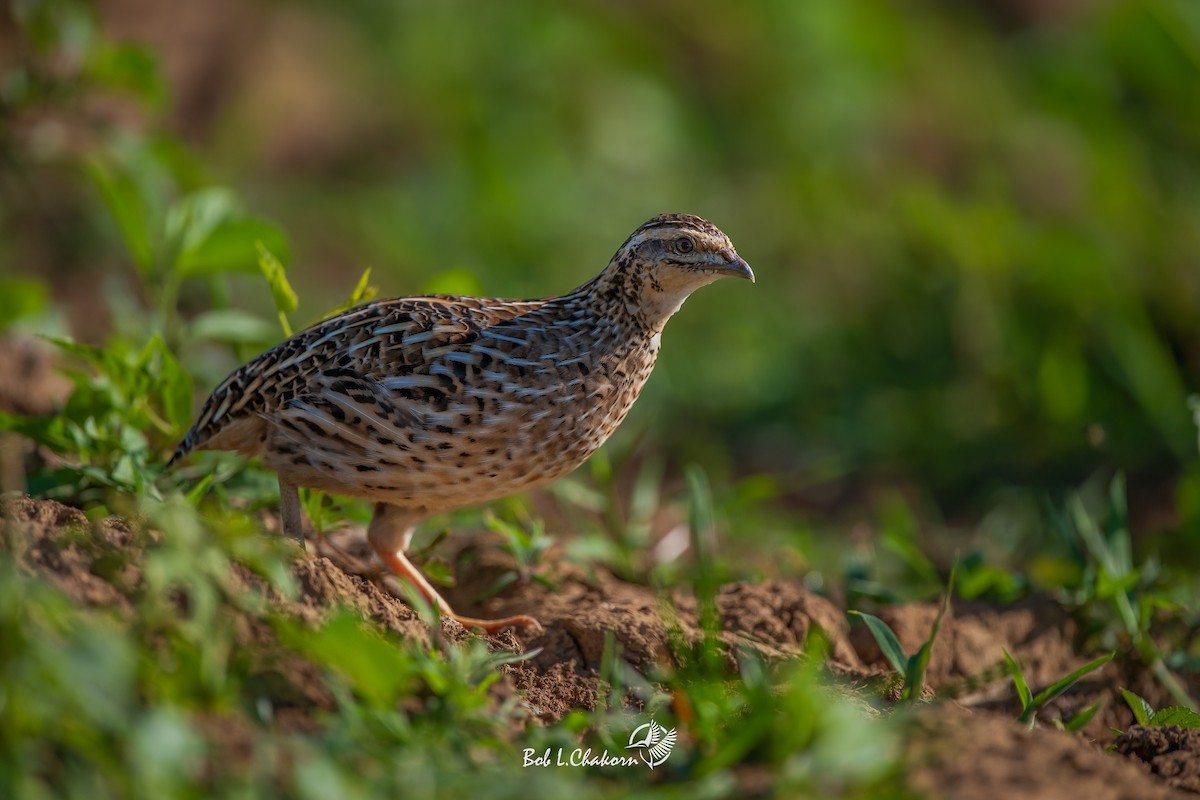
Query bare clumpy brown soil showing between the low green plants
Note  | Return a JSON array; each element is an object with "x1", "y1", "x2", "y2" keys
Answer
[{"x1": 0, "y1": 498, "x2": 1200, "y2": 800}]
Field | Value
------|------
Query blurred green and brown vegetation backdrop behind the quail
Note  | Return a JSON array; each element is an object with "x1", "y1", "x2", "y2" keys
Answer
[{"x1": 0, "y1": 0, "x2": 1200, "y2": 532}]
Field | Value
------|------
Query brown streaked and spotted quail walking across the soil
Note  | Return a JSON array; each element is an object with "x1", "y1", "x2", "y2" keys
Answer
[{"x1": 172, "y1": 215, "x2": 754, "y2": 630}]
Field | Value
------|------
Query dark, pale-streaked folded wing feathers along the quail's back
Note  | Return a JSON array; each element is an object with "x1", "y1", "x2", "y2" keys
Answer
[{"x1": 168, "y1": 295, "x2": 544, "y2": 465}]
